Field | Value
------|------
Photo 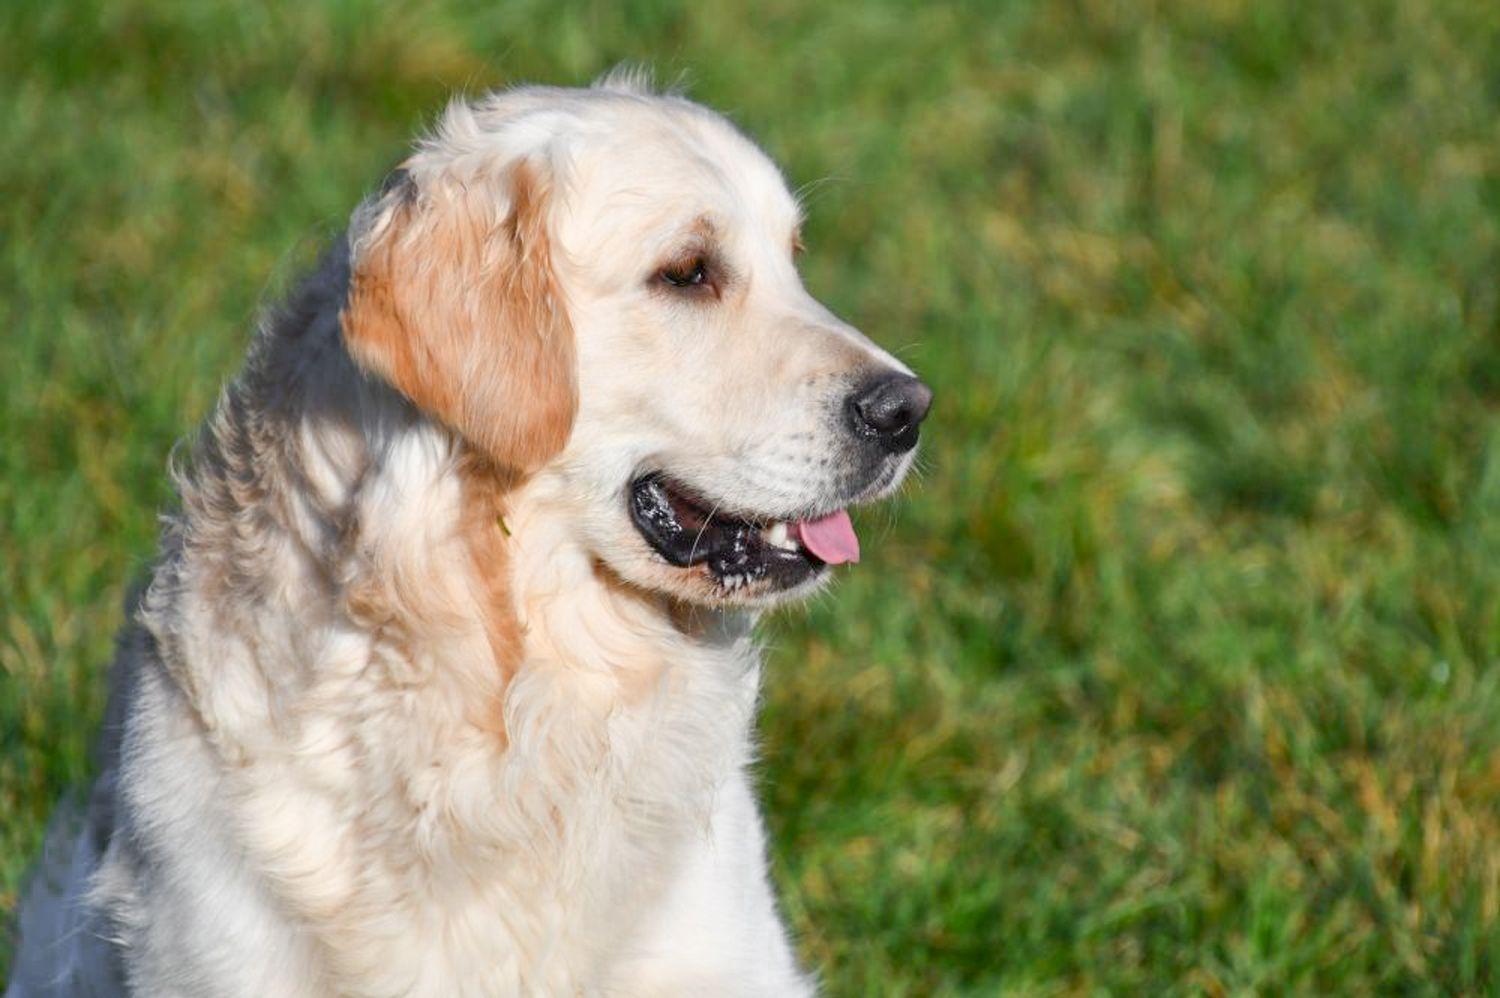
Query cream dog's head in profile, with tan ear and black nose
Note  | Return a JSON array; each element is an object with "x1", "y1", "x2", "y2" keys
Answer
[{"x1": 342, "y1": 83, "x2": 932, "y2": 603}]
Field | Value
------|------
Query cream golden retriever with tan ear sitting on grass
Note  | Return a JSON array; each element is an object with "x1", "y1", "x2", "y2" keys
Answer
[{"x1": 6, "y1": 74, "x2": 932, "y2": 998}]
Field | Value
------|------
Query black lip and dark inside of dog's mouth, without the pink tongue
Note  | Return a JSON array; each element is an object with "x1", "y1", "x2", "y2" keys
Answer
[{"x1": 629, "y1": 471, "x2": 827, "y2": 590}]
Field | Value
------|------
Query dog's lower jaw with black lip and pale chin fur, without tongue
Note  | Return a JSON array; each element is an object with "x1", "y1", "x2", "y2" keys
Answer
[{"x1": 627, "y1": 473, "x2": 831, "y2": 608}]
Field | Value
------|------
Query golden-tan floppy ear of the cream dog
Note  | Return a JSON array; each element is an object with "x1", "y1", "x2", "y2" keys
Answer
[{"x1": 339, "y1": 161, "x2": 578, "y2": 473}]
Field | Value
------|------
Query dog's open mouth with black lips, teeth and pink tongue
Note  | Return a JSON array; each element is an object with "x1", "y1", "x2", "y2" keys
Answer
[{"x1": 630, "y1": 473, "x2": 860, "y2": 590}]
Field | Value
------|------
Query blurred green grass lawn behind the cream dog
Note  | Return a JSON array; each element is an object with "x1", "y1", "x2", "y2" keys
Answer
[{"x1": 0, "y1": 0, "x2": 1500, "y2": 995}]
